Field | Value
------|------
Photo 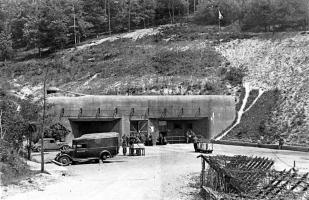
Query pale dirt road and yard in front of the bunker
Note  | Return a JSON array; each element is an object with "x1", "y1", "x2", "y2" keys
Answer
[{"x1": 5, "y1": 144, "x2": 309, "y2": 200}]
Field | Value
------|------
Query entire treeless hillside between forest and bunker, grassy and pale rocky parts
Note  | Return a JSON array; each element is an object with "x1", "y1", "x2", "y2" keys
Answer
[{"x1": 0, "y1": 24, "x2": 309, "y2": 144}]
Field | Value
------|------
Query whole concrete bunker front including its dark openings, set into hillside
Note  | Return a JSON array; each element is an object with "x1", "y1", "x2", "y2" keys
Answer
[{"x1": 48, "y1": 95, "x2": 235, "y2": 142}]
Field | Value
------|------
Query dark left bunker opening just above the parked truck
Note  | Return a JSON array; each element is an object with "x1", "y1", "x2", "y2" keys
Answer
[{"x1": 69, "y1": 118, "x2": 121, "y2": 137}]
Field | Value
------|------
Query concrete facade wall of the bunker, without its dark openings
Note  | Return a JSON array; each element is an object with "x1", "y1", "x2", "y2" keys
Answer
[{"x1": 48, "y1": 95, "x2": 235, "y2": 141}]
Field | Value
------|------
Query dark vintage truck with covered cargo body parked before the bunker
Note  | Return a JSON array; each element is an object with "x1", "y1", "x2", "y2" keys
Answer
[{"x1": 54, "y1": 132, "x2": 120, "y2": 166}]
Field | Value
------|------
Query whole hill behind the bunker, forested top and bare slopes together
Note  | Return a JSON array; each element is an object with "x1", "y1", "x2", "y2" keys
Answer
[{"x1": 0, "y1": 0, "x2": 309, "y2": 145}]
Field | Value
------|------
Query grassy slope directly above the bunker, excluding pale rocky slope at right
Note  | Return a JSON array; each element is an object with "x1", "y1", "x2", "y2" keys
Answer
[{"x1": 1, "y1": 24, "x2": 245, "y2": 95}]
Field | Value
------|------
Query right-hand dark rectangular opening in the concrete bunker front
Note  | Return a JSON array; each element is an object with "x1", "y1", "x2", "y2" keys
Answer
[{"x1": 158, "y1": 117, "x2": 210, "y2": 143}]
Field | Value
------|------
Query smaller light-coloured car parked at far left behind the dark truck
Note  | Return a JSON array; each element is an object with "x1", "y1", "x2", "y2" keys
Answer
[{"x1": 32, "y1": 138, "x2": 70, "y2": 151}]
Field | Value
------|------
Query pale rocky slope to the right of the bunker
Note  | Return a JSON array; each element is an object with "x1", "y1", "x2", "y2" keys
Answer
[{"x1": 217, "y1": 32, "x2": 309, "y2": 144}]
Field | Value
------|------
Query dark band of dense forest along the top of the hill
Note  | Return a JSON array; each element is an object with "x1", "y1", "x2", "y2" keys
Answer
[{"x1": 0, "y1": 0, "x2": 309, "y2": 60}]
